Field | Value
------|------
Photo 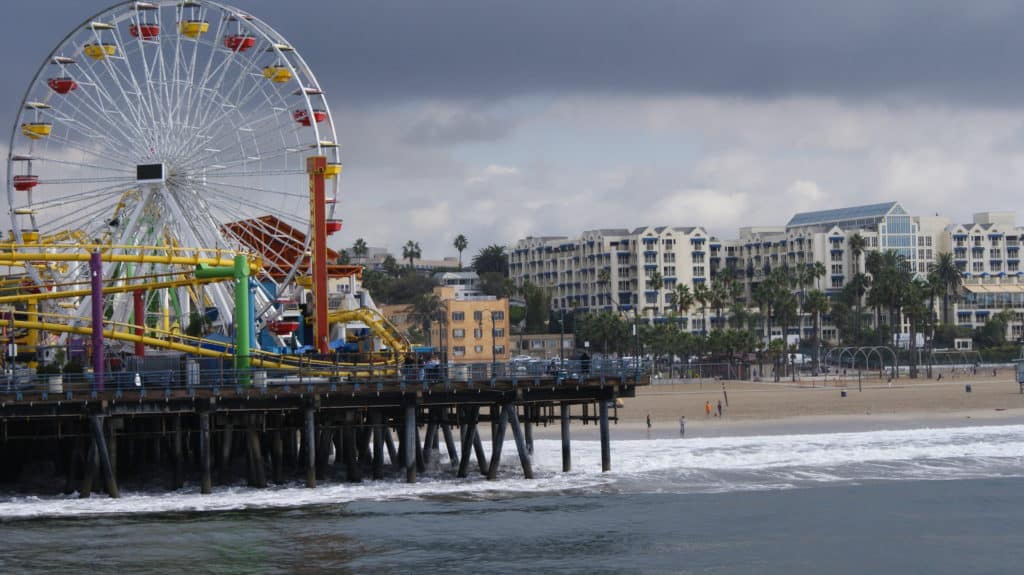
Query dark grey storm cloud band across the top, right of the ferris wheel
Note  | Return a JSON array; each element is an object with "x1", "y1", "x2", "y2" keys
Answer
[{"x1": 241, "y1": 0, "x2": 1024, "y2": 102}]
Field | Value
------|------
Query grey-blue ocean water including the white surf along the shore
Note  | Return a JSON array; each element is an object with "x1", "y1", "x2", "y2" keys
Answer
[{"x1": 0, "y1": 425, "x2": 1024, "y2": 575}]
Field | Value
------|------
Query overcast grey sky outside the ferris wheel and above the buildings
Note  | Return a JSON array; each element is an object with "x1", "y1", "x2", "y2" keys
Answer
[{"x1": 6, "y1": 0, "x2": 1024, "y2": 258}]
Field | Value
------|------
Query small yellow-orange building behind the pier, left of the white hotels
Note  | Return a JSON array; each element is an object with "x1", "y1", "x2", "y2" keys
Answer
[{"x1": 432, "y1": 285, "x2": 511, "y2": 363}]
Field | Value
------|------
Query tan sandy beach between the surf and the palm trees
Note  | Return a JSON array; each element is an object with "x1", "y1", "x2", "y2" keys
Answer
[{"x1": 589, "y1": 369, "x2": 1024, "y2": 436}]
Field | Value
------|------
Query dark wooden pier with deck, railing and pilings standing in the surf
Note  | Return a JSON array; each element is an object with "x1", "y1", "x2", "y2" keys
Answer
[{"x1": 0, "y1": 364, "x2": 649, "y2": 497}]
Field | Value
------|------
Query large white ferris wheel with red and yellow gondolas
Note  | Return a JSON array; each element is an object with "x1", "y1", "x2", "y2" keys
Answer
[{"x1": 7, "y1": 0, "x2": 341, "y2": 333}]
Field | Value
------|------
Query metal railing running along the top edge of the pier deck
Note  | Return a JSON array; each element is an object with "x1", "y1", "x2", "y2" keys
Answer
[{"x1": 0, "y1": 360, "x2": 645, "y2": 401}]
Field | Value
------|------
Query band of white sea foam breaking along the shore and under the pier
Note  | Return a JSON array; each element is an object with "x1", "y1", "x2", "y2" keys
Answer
[{"x1": 0, "y1": 426, "x2": 1024, "y2": 519}]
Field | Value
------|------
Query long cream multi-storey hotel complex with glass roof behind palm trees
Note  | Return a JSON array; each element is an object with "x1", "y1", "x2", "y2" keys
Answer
[{"x1": 509, "y1": 202, "x2": 1024, "y2": 342}]
